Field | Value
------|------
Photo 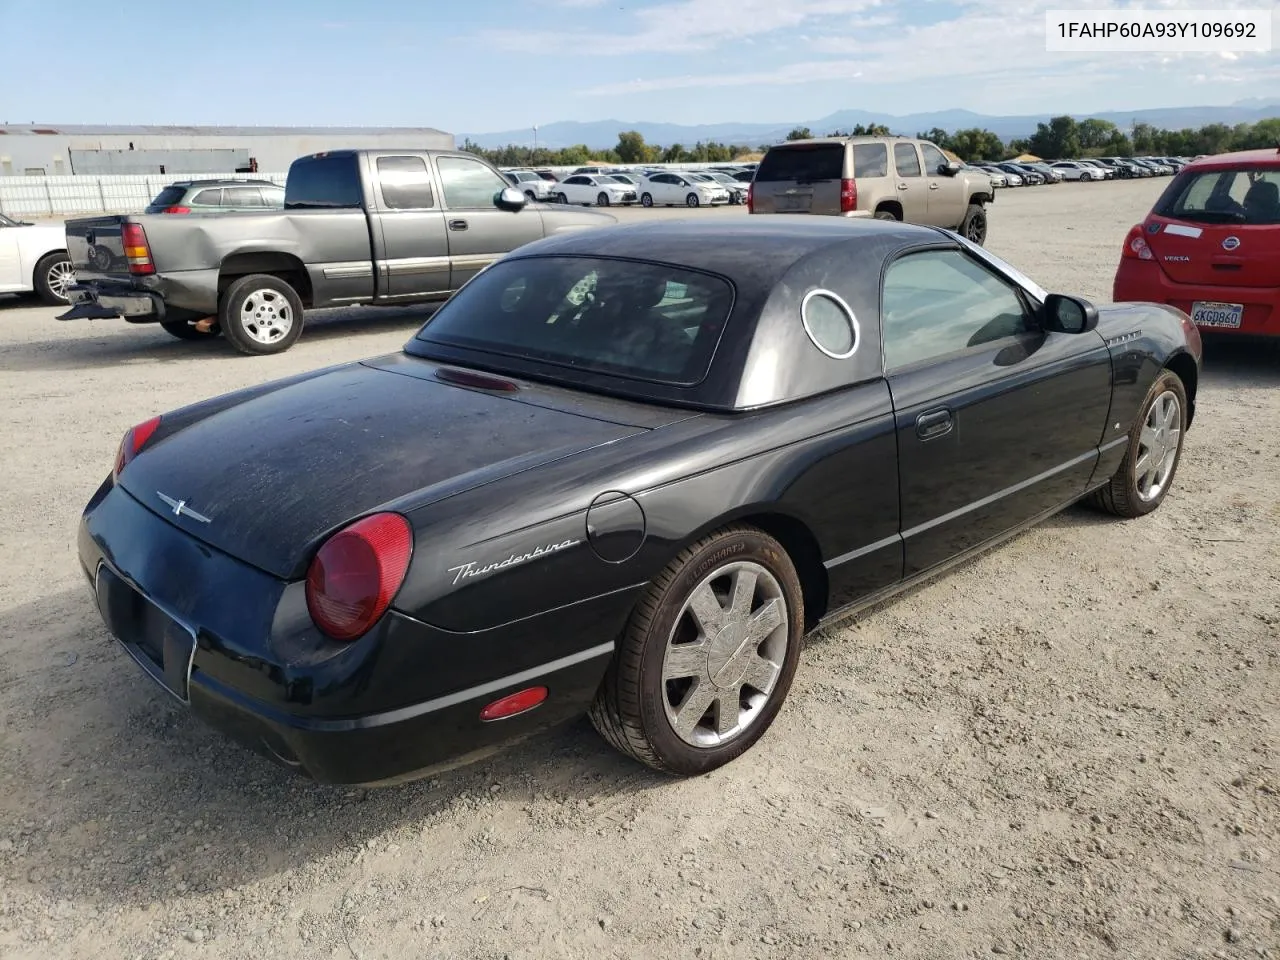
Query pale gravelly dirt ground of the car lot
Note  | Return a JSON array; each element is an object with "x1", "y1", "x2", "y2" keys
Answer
[{"x1": 0, "y1": 180, "x2": 1280, "y2": 960}]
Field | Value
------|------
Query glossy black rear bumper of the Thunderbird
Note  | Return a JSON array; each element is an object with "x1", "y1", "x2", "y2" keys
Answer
[{"x1": 77, "y1": 480, "x2": 631, "y2": 785}]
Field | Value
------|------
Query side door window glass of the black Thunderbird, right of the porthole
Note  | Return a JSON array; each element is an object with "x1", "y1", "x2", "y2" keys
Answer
[{"x1": 881, "y1": 250, "x2": 1032, "y2": 370}]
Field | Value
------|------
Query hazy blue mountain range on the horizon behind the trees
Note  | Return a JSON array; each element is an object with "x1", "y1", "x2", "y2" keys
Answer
[{"x1": 457, "y1": 97, "x2": 1280, "y2": 150}]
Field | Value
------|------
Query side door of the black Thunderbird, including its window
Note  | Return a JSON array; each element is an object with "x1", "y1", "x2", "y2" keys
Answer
[{"x1": 881, "y1": 244, "x2": 1111, "y2": 576}]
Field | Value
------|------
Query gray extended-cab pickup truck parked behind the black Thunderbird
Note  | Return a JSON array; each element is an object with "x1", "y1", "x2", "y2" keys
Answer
[{"x1": 58, "y1": 150, "x2": 616, "y2": 353}]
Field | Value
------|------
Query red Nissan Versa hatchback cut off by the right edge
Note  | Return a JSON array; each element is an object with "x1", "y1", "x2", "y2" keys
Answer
[{"x1": 1112, "y1": 148, "x2": 1280, "y2": 335}]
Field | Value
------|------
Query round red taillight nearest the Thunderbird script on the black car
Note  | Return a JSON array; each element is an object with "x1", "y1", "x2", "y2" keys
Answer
[{"x1": 307, "y1": 513, "x2": 413, "y2": 640}]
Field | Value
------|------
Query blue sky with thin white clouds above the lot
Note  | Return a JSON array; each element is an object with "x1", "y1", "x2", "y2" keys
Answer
[{"x1": 0, "y1": 0, "x2": 1280, "y2": 133}]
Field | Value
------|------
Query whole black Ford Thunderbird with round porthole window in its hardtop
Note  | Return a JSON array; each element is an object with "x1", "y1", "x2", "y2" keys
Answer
[{"x1": 78, "y1": 216, "x2": 1201, "y2": 783}]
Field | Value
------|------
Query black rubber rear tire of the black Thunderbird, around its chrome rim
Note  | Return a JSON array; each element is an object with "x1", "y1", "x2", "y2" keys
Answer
[{"x1": 589, "y1": 525, "x2": 804, "y2": 776}]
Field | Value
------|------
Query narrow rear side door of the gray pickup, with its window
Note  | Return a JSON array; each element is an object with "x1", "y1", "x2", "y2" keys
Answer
[{"x1": 370, "y1": 154, "x2": 453, "y2": 300}]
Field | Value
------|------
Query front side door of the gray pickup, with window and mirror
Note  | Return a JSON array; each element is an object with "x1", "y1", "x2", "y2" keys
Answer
[{"x1": 435, "y1": 155, "x2": 543, "y2": 289}]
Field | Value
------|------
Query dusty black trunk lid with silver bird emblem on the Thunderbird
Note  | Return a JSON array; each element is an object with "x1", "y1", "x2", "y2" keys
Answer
[{"x1": 120, "y1": 360, "x2": 670, "y2": 579}]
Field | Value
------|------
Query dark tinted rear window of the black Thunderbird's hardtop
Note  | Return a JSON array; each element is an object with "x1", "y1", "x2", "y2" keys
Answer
[{"x1": 417, "y1": 257, "x2": 733, "y2": 385}]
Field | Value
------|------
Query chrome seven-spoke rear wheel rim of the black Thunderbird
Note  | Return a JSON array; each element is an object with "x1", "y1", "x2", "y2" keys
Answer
[{"x1": 662, "y1": 562, "x2": 790, "y2": 748}]
